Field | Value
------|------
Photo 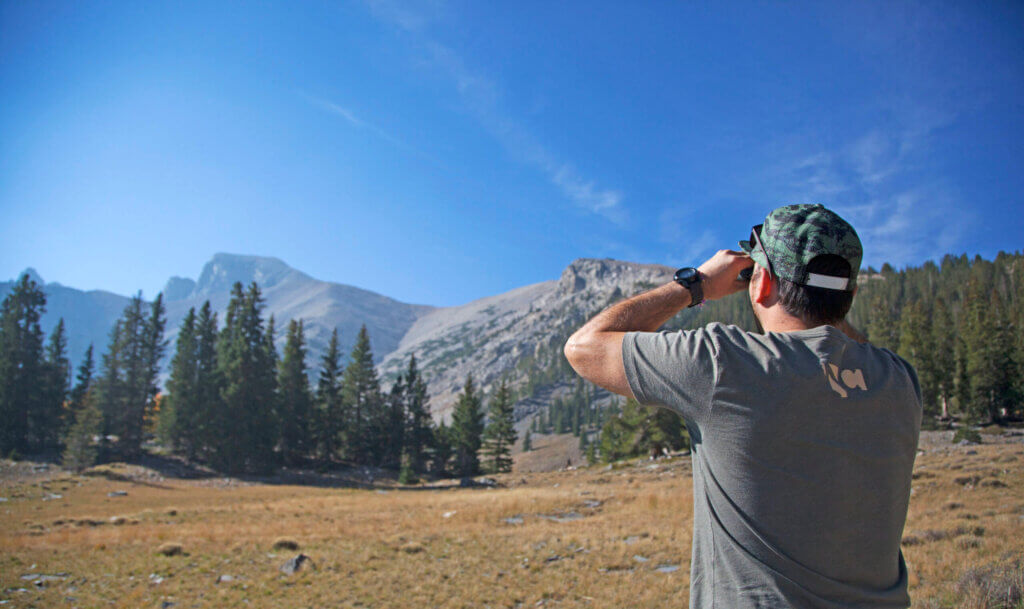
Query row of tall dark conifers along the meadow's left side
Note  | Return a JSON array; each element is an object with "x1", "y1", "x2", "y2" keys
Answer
[{"x1": 0, "y1": 275, "x2": 516, "y2": 481}]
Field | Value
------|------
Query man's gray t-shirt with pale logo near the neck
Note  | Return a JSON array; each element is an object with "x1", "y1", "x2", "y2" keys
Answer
[{"x1": 623, "y1": 323, "x2": 922, "y2": 609}]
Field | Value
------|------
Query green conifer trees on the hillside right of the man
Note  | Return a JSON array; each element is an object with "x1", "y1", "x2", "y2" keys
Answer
[{"x1": 849, "y1": 252, "x2": 1024, "y2": 424}]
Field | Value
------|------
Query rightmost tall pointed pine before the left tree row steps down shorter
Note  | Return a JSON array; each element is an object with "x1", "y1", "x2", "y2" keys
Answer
[{"x1": 341, "y1": 325, "x2": 382, "y2": 463}]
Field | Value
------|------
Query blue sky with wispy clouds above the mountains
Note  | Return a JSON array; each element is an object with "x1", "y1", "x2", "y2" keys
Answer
[{"x1": 0, "y1": 0, "x2": 1024, "y2": 305}]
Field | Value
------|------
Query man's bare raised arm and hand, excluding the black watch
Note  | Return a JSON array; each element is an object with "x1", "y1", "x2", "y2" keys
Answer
[{"x1": 565, "y1": 250, "x2": 754, "y2": 397}]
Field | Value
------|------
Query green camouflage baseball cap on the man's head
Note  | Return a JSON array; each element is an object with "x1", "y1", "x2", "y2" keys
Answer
[{"x1": 739, "y1": 204, "x2": 863, "y2": 292}]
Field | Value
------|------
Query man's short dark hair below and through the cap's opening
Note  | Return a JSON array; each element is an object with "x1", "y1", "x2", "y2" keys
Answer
[{"x1": 776, "y1": 254, "x2": 853, "y2": 325}]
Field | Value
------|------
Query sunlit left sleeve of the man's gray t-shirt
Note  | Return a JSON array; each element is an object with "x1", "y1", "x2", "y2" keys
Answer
[{"x1": 623, "y1": 329, "x2": 717, "y2": 423}]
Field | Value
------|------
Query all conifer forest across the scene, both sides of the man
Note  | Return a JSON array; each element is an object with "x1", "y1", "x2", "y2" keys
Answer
[{"x1": 0, "y1": 253, "x2": 1024, "y2": 474}]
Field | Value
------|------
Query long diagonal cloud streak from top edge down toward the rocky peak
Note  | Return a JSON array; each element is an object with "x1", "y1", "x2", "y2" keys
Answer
[{"x1": 366, "y1": 0, "x2": 628, "y2": 224}]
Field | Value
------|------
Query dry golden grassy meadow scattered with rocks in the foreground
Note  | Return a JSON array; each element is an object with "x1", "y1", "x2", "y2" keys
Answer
[{"x1": 0, "y1": 436, "x2": 1024, "y2": 608}]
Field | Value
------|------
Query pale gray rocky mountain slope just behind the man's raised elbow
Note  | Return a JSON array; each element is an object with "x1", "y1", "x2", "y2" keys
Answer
[{"x1": 378, "y1": 258, "x2": 673, "y2": 419}]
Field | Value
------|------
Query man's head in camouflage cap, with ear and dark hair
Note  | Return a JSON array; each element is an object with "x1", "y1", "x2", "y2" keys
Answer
[{"x1": 739, "y1": 205, "x2": 863, "y2": 325}]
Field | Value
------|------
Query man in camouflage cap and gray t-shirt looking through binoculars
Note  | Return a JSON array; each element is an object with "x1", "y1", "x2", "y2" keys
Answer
[{"x1": 565, "y1": 205, "x2": 922, "y2": 609}]
